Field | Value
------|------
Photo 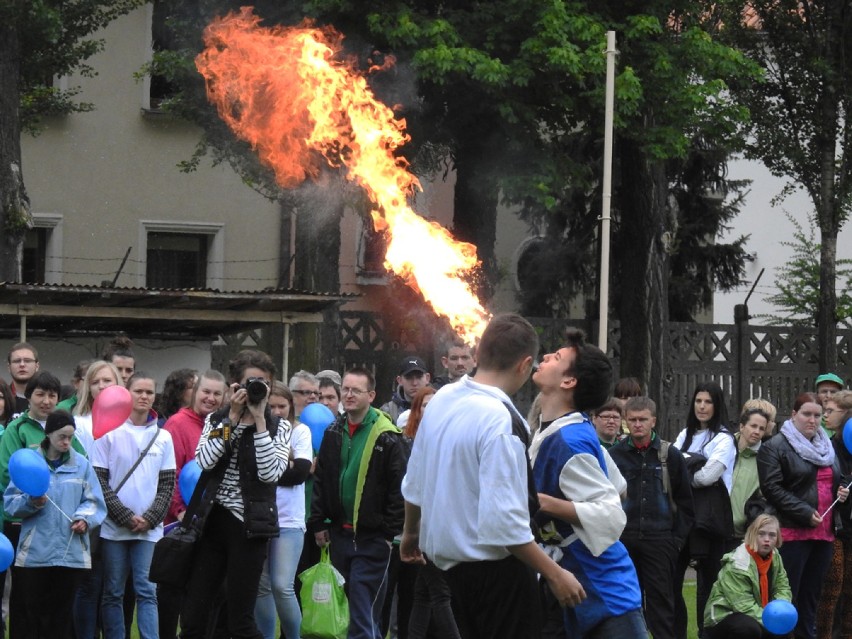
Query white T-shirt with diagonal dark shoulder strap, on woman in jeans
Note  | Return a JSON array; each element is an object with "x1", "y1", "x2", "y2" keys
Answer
[{"x1": 92, "y1": 421, "x2": 175, "y2": 541}]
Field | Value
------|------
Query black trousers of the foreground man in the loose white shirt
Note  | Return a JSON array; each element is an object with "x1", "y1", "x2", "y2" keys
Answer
[{"x1": 444, "y1": 555, "x2": 541, "y2": 639}]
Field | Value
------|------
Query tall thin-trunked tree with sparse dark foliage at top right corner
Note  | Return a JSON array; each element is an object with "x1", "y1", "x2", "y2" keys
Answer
[{"x1": 715, "y1": 0, "x2": 852, "y2": 370}]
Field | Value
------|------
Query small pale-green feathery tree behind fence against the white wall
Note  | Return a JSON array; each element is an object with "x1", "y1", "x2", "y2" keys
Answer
[{"x1": 759, "y1": 213, "x2": 852, "y2": 330}]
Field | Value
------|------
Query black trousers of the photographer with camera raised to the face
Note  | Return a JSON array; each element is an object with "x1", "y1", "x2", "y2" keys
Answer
[{"x1": 180, "y1": 504, "x2": 268, "y2": 639}]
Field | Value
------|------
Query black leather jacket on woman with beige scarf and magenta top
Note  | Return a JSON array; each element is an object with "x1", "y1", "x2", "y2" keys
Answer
[{"x1": 757, "y1": 433, "x2": 840, "y2": 528}]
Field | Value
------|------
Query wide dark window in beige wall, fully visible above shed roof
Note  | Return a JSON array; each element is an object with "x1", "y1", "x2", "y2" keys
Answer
[{"x1": 145, "y1": 232, "x2": 208, "y2": 288}]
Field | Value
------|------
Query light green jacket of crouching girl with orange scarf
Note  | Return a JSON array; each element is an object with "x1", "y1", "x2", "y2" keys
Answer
[{"x1": 704, "y1": 544, "x2": 793, "y2": 627}]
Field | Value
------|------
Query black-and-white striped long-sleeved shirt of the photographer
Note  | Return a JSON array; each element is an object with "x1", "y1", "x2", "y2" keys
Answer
[{"x1": 195, "y1": 415, "x2": 292, "y2": 521}]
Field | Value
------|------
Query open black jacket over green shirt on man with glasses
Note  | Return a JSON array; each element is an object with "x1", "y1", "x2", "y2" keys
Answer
[{"x1": 308, "y1": 414, "x2": 408, "y2": 541}]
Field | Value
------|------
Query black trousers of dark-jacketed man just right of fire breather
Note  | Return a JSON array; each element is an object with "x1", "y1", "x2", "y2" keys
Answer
[{"x1": 621, "y1": 539, "x2": 679, "y2": 639}]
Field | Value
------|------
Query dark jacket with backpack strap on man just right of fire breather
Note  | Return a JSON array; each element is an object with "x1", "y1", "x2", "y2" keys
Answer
[{"x1": 609, "y1": 436, "x2": 694, "y2": 548}]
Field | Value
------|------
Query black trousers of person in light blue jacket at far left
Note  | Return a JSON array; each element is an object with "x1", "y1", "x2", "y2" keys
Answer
[{"x1": 13, "y1": 566, "x2": 86, "y2": 639}]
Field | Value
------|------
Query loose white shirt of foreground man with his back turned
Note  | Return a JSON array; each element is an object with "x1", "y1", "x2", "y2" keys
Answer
[{"x1": 402, "y1": 376, "x2": 533, "y2": 570}]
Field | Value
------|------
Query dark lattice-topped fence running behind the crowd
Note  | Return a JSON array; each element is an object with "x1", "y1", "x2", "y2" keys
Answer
[{"x1": 214, "y1": 311, "x2": 852, "y2": 439}]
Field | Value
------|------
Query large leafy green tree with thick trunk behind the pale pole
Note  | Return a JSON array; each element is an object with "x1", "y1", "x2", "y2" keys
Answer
[{"x1": 302, "y1": 0, "x2": 755, "y2": 404}]
